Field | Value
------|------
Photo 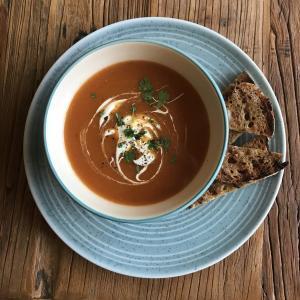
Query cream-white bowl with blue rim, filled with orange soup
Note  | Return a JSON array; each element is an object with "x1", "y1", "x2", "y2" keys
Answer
[{"x1": 44, "y1": 41, "x2": 229, "y2": 221}]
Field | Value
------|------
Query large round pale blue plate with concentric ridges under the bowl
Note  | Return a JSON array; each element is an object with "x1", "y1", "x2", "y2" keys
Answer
[{"x1": 24, "y1": 18, "x2": 285, "y2": 278}]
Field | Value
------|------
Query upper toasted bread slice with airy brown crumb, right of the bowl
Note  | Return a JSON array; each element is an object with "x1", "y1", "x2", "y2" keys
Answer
[{"x1": 224, "y1": 73, "x2": 274, "y2": 137}]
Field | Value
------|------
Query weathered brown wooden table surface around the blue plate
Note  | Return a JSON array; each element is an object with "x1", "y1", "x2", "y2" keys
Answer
[{"x1": 0, "y1": 0, "x2": 300, "y2": 300}]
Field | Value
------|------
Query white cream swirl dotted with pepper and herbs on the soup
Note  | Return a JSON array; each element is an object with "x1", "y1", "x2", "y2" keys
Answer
[{"x1": 80, "y1": 92, "x2": 183, "y2": 185}]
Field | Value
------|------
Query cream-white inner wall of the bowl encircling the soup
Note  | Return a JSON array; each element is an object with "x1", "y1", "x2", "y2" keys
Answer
[{"x1": 44, "y1": 41, "x2": 229, "y2": 221}]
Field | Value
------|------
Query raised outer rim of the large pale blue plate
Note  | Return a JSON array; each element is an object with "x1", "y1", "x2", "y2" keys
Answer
[{"x1": 23, "y1": 17, "x2": 286, "y2": 278}]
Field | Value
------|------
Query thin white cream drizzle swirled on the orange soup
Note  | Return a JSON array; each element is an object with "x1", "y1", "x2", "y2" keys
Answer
[{"x1": 80, "y1": 86, "x2": 184, "y2": 185}]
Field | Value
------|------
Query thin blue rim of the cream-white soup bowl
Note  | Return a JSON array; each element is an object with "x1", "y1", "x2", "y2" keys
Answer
[{"x1": 43, "y1": 39, "x2": 229, "y2": 223}]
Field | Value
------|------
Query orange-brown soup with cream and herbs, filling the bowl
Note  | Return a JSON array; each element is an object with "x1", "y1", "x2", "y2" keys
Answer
[{"x1": 64, "y1": 61, "x2": 209, "y2": 205}]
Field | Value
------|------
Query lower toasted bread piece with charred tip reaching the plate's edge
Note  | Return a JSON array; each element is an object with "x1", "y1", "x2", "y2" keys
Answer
[{"x1": 191, "y1": 136, "x2": 287, "y2": 208}]
